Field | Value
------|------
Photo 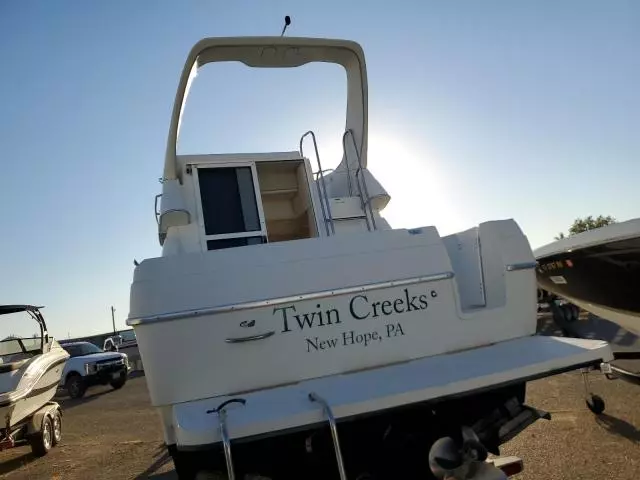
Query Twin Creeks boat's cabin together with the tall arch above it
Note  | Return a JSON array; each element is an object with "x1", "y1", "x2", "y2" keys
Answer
[{"x1": 156, "y1": 38, "x2": 389, "y2": 256}]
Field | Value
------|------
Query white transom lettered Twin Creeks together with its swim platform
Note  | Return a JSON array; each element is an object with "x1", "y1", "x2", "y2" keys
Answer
[{"x1": 124, "y1": 221, "x2": 612, "y2": 448}]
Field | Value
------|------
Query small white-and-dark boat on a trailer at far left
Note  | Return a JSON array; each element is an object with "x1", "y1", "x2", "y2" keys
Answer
[{"x1": 0, "y1": 305, "x2": 69, "y2": 438}]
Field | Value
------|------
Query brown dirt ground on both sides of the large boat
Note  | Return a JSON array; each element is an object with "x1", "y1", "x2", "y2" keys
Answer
[{"x1": 0, "y1": 316, "x2": 640, "y2": 480}]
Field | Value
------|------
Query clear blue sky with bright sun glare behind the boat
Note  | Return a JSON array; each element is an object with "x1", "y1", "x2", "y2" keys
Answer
[{"x1": 0, "y1": 0, "x2": 640, "y2": 338}]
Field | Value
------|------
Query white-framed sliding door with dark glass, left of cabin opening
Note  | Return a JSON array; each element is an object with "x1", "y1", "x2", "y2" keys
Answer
[{"x1": 197, "y1": 166, "x2": 266, "y2": 250}]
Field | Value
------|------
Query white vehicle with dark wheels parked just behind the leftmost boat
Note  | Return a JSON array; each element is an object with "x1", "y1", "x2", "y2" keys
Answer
[{"x1": 59, "y1": 342, "x2": 129, "y2": 398}]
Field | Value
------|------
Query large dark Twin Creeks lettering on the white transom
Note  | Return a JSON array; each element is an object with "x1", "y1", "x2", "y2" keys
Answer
[{"x1": 273, "y1": 288, "x2": 438, "y2": 333}]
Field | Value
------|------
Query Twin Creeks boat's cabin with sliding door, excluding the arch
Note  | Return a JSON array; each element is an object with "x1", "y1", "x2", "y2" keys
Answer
[{"x1": 156, "y1": 147, "x2": 388, "y2": 254}]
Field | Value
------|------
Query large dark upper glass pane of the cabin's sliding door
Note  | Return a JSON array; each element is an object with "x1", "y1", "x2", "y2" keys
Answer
[{"x1": 198, "y1": 167, "x2": 260, "y2": 235}]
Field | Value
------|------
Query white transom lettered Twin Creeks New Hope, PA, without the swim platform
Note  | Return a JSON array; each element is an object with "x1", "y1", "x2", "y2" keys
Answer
[{"x1": 129, "y1": 221, "x2": 536, "y2": 406}]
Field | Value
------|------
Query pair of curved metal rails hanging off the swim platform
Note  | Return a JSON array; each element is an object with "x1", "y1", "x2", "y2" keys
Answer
[{"x1": 207, "y1": 392, "x2": 347, "y2": 480}]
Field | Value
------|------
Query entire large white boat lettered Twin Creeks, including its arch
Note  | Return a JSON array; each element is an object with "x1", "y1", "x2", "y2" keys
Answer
[{"x1": 127, "y1": 37, "x2": 612, "y2": 479}]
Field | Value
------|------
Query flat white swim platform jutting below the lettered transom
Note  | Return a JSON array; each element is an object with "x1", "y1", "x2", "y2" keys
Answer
[{"x1": 171, "y1": 336, "x2": 613, "y2": 448}]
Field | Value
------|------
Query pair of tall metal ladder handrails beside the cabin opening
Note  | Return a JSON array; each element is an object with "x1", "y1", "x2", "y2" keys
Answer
[{"x1": 300, "y1": 129, "x2": 377, "y2": 235}]
